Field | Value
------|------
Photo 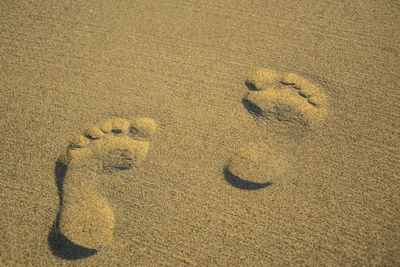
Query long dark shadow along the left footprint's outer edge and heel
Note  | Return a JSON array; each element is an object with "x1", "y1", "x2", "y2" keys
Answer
[{"x1": 47, "y1": 160, "x2": 97, "y2": 260}]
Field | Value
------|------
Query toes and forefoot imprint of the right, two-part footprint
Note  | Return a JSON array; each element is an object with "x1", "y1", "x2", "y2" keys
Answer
[{"x1": 243, "y1": 69, "x2": 327, "y2": 128}]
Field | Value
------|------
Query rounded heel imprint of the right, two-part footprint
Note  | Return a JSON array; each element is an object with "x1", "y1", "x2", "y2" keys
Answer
[{"x1": 227, "y1": 143, "x2": 286, "y2": 183}]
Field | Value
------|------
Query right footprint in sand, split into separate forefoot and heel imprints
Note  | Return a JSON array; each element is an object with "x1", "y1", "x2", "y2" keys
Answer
[{"x1": 225, "y1": 69, "x2": 327, "y2": 190}]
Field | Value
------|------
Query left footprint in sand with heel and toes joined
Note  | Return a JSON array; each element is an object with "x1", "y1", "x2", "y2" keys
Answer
[{"x1": 57, "y1": 118, "x2": 156, "y2": 249}]
